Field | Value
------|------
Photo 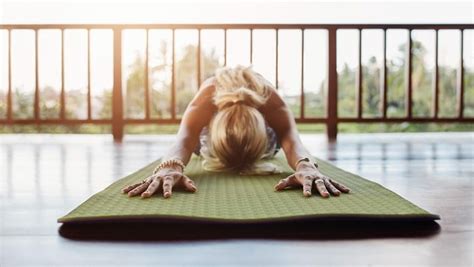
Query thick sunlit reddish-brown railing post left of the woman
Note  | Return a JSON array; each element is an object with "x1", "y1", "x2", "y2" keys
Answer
[{"x1": 112, "y1": 28, "x2": 124, "y2": 142}]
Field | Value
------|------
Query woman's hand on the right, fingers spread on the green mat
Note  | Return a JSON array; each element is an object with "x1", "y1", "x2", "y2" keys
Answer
[{"x1": 275, "y1": 162, "x2": 350, "y2": 198}]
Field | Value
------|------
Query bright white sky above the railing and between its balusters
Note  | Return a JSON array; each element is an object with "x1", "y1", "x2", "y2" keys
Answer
[{"x1": 0, "y1": 0, "x2": 474, "y2": 99}]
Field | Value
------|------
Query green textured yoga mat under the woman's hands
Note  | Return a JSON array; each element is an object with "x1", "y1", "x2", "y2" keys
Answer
[{"x1": 58, "y1": 151, "x2": 439, "y2": 224}]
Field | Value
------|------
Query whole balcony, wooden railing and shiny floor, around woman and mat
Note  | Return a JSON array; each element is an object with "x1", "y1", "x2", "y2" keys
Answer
[{"x1": 0, "y1": 21, "x2": 474, "y2": 266}]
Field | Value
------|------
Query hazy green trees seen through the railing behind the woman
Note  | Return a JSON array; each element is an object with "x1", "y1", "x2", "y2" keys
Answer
[{"x1": 0, "y1": 38, "x2": 474, "y2": 133}]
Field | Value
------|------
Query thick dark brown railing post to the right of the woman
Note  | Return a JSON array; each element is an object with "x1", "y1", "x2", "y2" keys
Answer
[{"x1": 326, "y1": 28, "x2": 337, "y2": 142}]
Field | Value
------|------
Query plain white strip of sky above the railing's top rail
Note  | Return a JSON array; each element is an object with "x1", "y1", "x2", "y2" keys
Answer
[{"x1": 0, "y1": 0, "x2": 474, "y2": 23}]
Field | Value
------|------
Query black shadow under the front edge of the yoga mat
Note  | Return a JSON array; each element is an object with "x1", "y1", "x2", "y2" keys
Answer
[{"x1": 59, "y1": 219, "x2": 441, "y2": 241}]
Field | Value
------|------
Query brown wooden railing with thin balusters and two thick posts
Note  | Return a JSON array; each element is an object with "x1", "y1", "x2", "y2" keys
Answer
[{"x1": 0, "y1": 24, "x2": 474, "y2": 141}]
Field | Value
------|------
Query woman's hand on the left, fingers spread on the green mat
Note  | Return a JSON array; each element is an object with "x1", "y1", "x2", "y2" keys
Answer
[{"x1": 122, "y1": 166, "x2": 197, "y2": 198}]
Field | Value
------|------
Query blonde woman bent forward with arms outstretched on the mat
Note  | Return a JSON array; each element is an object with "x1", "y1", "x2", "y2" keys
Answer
[{"x1": 122, "y1": 66, "x2": 349, "y2": 198}]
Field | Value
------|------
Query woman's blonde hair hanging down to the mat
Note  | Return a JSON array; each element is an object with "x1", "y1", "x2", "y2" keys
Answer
[{"x1": 201, "y1": 66, "x2": 280, "y2": 175}]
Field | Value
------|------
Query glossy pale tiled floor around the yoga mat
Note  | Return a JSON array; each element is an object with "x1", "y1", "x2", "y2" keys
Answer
[{"x1": 0, "y1": 133, "x2": 474, "y2": 267}]
